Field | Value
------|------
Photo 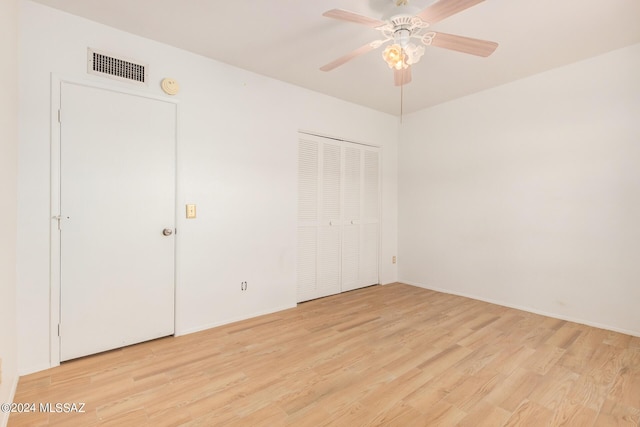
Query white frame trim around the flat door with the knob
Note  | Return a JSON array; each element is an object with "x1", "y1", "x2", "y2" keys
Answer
[{"x1": 49, "y1": 73, "x2": 180, "y2": 367}]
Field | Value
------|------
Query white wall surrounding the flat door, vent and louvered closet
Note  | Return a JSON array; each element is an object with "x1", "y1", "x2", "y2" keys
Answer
[{"x1": 18, "y1": 0, "x2": 398, "y2": 373}]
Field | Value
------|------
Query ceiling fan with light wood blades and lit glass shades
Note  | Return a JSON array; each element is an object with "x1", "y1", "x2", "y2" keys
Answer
[{"x1": 320, "y1": 0, "x2": 498, "y2": 86}]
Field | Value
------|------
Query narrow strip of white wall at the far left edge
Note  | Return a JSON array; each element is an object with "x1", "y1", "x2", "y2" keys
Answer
[{"x1": 0, "y1": 0, "x2": 19, "y2": 425}]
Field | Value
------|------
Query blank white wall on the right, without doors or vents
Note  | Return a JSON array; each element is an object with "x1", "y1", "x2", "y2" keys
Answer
[{"x1": 399, "y1": 45, "x2": 640, "y2": 335}]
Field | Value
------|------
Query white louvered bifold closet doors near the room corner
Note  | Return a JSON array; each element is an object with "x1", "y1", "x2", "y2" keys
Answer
[{"x1": 298, "y1": 134, "x2": 379, "y2": 302}]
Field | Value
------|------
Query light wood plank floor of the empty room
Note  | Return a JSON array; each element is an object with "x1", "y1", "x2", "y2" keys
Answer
[{"x1": 9, "y1": 284, "x2": 640, "y2": 427}]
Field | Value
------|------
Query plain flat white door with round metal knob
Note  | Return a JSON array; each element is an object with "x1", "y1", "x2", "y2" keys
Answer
[{"x1": 60, "y1": 83, "x2": 176, "y2": 361}]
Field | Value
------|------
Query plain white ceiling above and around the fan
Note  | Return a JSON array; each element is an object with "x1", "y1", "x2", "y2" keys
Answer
[{"x1": 28, "y1": 0, "x2": 640, "y2": 115}]
